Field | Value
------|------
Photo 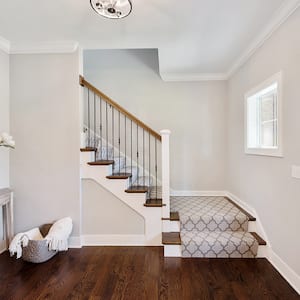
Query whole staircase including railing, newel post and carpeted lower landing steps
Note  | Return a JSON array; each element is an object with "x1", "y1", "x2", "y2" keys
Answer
[{"x1": 80, "y1": 77, "x2": 265, "y2": 258}]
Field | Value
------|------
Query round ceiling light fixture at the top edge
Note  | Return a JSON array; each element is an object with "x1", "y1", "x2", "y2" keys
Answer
[{"x1": 90, "y1": 0, "x2": 132, "y2": 19}]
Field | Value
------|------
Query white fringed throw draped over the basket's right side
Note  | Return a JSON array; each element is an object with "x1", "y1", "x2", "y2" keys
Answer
[{"x1": 45, "y1": 217, "x2": 73, "y2": 251}]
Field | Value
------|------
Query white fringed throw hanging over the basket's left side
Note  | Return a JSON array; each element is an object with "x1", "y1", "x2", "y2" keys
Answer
[{"x1": 9, "y1": 228, "x2": 43, "y2": 258}]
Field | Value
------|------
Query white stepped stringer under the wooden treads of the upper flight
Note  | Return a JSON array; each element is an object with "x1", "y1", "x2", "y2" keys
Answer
[{"x1": 80, "y1": 152, "x2": 162, "y2": 246}]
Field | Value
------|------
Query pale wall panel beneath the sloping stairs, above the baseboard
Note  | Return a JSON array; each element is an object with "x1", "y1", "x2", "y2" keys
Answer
[{"x1": 82, "y1": 180, "x2": 145, "y2": 235}]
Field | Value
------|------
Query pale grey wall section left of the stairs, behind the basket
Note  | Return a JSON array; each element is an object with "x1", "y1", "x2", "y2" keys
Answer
[{"x1": 10, "y1": 53, "x2": 80, "y2": 236}]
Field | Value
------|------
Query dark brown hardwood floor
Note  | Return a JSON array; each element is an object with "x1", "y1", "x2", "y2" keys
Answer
[{"x1": 0, "y1": 247, "x2": 300, "y2": 300}]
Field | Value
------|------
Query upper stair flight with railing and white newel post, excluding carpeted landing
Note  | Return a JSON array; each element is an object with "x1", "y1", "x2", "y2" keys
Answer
[{"x1": 80, "y1": 77, "x2": 170, "y2": 245}]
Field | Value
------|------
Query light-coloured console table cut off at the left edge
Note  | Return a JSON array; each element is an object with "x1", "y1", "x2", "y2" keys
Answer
[{"x1": 0, "y1": 188, "x2": 14, "y2": 251}]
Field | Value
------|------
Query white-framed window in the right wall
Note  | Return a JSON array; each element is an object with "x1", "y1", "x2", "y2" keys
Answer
[{"x1": 245, "y1": 73, "x2": 282, "y2": 156}]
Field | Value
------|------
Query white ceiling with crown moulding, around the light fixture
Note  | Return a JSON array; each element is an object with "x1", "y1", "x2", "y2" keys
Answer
[{"x1": 0, "y1": 0, "x2": 300, "y2": 80}]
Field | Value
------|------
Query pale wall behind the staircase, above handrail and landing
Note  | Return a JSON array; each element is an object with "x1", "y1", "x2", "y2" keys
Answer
[{"x1": 84, "y1": 49, "x2": 226, "y2": 190}]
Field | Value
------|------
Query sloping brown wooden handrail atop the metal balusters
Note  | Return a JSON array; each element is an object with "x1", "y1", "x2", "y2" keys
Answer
[{"x1": 79, "y1": 75, "x2": 161, "y2": 141}]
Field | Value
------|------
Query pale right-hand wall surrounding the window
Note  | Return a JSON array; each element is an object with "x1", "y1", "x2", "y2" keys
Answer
[{"x1": 226, "y1": 9, "x2": 300, "y2": 274}]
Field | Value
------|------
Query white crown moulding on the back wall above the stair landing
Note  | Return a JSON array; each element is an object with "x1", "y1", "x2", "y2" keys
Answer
[{"x1": 159, "y1": 72, "x2": 228, "y2": 82}]
